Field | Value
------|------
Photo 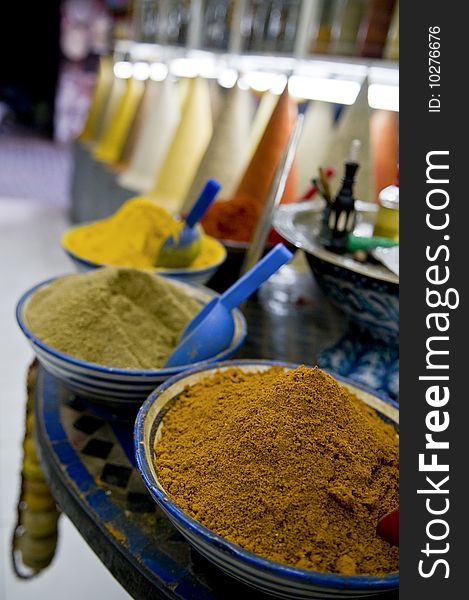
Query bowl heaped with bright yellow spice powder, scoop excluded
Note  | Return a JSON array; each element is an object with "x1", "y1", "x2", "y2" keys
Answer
[{"x1": 62, "y1": 197, "x2": 227, "y2": 285}]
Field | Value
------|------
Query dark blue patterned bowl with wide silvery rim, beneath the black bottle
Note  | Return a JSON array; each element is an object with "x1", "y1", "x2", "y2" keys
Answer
[{"x1": 274, "y1": 200, "x2": 399, "y2": 343}]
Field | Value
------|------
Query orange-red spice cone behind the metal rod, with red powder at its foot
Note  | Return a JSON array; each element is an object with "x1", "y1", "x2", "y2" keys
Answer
[{"x1": 201, "y1": 88, "x2": 297, "y2": 242}]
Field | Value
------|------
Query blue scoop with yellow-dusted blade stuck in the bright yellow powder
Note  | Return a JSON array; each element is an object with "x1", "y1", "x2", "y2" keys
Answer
[{"x1": 156, "y1": 179, "x2": 221, "y2": 269}]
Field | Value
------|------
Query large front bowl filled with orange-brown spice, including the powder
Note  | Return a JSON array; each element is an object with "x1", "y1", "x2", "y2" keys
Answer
[{"x1": 134, "y1": 360, "x2": 399, "y2": 598}]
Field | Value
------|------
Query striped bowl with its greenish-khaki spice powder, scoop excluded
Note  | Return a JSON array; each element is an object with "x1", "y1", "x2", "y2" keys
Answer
[{"x1": 16, "y1": 267, "x2": 247, "y2": 408}]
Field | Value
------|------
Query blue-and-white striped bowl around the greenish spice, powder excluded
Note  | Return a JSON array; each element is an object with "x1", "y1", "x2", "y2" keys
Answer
[{"x1": 16, "y1": 278, "x2": 247, "y2": 409}]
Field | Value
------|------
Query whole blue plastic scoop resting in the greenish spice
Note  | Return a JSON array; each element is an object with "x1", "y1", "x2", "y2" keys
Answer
[{"x1": 166, "y1": 244, "x2": 293, "y2": 367}]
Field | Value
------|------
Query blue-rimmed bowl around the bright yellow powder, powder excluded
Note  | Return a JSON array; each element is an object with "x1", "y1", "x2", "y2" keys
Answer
[{"x1": 62, "y1": 230, "x2": 227, "y2": 285}]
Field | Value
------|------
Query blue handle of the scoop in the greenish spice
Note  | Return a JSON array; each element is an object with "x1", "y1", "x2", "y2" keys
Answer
[{"x1": 218, "y1": 244, "x2": 293, "y2": 310}]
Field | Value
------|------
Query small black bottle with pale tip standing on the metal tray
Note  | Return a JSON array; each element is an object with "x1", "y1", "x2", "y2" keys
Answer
[{"x1": 321, "y1": 140, "x2": 361, "y2": 254}]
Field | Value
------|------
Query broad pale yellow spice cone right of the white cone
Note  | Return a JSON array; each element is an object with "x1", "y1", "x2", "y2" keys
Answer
[{"x1": 149, "y1": 78, "x2": 212, "y2": 214}]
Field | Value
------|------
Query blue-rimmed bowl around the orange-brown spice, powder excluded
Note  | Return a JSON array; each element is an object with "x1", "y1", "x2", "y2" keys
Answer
[{"x1": 134, "y1": 360, "x2": 399, "y2": 598}]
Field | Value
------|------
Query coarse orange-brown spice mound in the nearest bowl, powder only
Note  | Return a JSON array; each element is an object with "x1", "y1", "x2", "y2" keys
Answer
[{"x1": 155, "y1": 367, "x2": 399, "y2": 575}]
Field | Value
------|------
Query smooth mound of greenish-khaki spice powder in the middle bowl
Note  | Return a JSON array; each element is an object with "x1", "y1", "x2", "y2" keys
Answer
[{"x1": 25, "y1": 267, "x2": 201, "y2": 369}]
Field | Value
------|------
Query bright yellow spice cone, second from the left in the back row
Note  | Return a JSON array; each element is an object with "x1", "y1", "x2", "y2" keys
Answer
[{"x1": 94, "y1": 77, "x2": 145, "y2": 163}]
